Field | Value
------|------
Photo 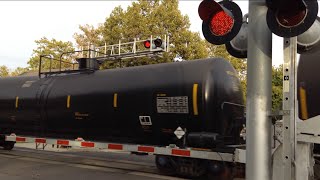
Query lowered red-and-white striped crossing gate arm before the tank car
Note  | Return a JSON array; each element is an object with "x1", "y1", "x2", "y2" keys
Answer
[{"x1": 5, "y1": 135, "x2": 245, "y2": 163}]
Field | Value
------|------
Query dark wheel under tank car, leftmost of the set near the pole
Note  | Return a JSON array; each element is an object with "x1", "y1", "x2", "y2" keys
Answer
[{"x1": 156, "y1": 155, "x2": 176, "y2": 175}]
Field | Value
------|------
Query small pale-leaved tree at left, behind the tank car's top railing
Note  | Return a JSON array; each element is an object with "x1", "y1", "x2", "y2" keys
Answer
[{"x1": 28, "y1": 37, "x2": 74, "y2": 70}]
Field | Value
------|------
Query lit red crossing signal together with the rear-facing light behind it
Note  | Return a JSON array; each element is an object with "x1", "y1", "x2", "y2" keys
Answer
[{"x1": 198, "y1": 0, "x2": 248, "y2": 58}]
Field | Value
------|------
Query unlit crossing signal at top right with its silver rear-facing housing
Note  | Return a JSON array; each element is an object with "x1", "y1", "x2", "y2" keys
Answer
[{"x1": 266, "y1": 0, "x2": 320, "y2": 54}]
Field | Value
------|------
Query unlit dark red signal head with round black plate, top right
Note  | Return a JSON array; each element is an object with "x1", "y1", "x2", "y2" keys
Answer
[{"x1": 267, "y1": 0, "x2": 318, "y2": 38}]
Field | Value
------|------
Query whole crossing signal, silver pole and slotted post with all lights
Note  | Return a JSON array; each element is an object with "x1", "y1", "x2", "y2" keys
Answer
[{"x1": 199, "y1": 0, "x2": 320, "y2": 180}]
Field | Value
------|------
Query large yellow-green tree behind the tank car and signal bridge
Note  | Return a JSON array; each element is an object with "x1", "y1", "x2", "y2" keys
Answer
[{"x1": 79, "y1": 0, "x2": 208, "y2": 68}]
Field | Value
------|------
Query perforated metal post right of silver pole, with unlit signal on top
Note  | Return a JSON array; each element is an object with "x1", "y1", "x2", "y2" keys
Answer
[{"x1": 266, "y1": 0, "x2": 320, "y2": 180}]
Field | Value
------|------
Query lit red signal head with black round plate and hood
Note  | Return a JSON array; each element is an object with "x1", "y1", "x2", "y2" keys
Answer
[{"x1": 198, "y1": 0, "x2": 242, "y2": 45}]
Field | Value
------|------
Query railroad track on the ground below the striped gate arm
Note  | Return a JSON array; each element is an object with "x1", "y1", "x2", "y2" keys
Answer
[{"x1": 0, "y1": 148, "x2": 185, "y2": 180}]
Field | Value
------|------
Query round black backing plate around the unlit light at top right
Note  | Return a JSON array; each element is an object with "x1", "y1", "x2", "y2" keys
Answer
[{"x1": 267, "y1": 0, "x2": 318, "y2": 38}]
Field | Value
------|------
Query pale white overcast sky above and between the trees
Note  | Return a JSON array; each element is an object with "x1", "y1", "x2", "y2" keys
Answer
[{"x1": 0, "y1": 0, "x2": 308, "y2": 70}]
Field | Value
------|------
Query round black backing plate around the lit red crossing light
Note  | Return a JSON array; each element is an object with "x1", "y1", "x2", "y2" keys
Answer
[{"x1": 202, "y1": 1, "x2": 242, "y2": 45}]
